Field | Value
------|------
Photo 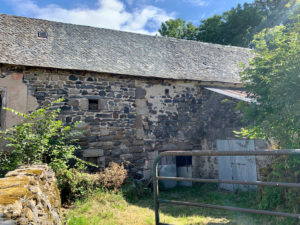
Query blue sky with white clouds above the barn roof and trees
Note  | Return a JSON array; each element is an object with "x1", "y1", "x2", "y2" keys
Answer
[{"x1": 0, "y1": 0, "x2": 252, "y2": 34}]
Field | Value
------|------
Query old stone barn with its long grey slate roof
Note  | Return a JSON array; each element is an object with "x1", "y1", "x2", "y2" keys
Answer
[{"x1": 0, "y1": 14, "x2": 258, "y2": 177}]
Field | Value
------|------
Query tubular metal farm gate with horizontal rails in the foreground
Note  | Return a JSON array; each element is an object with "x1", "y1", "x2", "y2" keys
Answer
[{"x1": 153, "y1": 149, "x2": 300, "y2": 225}]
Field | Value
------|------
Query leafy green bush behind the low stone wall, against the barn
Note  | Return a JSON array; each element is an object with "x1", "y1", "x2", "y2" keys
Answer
[{"x1": 0, "y1": 99, "x2": 82, "y2": 171}]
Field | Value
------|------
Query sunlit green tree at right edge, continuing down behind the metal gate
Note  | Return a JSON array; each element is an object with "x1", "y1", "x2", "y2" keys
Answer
[{"x1": 240, "y1": 5, "x2": 300, "y2": 218}]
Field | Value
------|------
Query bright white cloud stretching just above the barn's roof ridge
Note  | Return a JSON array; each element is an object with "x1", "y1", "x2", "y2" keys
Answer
[{"x1": 10, "y1": 0, "x2": 174, "y2": 34}]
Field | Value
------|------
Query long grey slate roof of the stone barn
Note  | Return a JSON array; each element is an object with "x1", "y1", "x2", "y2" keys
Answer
[{"x1": 0, "y1": 14, "x2": 253, "y2": 83}]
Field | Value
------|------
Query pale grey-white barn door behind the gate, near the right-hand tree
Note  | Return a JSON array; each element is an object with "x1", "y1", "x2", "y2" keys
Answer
[{"x1": 217, "y1": 140, "x2": 257, "y2": 191}]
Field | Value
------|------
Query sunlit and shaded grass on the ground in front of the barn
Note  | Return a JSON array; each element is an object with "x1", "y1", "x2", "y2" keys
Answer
[{"x1": 65, "y1": 185, "x2": 297, "y2": 225}]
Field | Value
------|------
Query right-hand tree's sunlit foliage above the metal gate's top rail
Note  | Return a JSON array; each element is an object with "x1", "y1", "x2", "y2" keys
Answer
[{"x1": 242, "y1": 3, "x2": 300, "y2": 148}]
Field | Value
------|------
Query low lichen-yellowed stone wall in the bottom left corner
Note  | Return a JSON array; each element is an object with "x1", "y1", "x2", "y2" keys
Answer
[{"x1": 0, "y1": 165, "x2": 61, "y2": 225}]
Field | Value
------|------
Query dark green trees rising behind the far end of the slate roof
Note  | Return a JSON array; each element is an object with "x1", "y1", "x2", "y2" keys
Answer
[{"x1": 159, "y1": 0, "x2": 296, "y2": 47}]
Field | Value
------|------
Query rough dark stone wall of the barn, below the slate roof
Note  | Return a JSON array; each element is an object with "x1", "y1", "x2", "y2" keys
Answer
[{"x1": 0, "y1": 64, "x2": 248, "y2": 178}]
